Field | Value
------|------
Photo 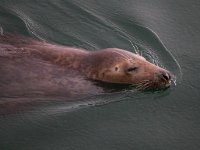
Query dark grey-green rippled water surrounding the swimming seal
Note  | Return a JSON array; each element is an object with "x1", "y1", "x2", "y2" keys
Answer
[{"x1": 0, "y1": 0, "x2": 200, "y2": 150}]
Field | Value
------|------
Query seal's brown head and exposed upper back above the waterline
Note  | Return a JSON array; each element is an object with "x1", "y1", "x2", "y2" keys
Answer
[{"x1": 0, "y1": 34, "x2": 171, "y2": 90}]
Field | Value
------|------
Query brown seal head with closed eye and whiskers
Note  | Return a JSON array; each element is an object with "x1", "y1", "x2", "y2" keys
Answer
[{"x1": 81, "y1": 48, "x2": 171, "y2": 89}]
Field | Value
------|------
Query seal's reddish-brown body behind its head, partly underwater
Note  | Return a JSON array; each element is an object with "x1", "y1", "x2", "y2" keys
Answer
[{"x1": 0, "y1": 34, "x2": 103, "y2": 113}]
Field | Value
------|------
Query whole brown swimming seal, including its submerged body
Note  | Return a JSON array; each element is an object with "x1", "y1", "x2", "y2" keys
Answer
[{"x1": 0, "y1": 33, "x2": 171, "y2": 113}]
